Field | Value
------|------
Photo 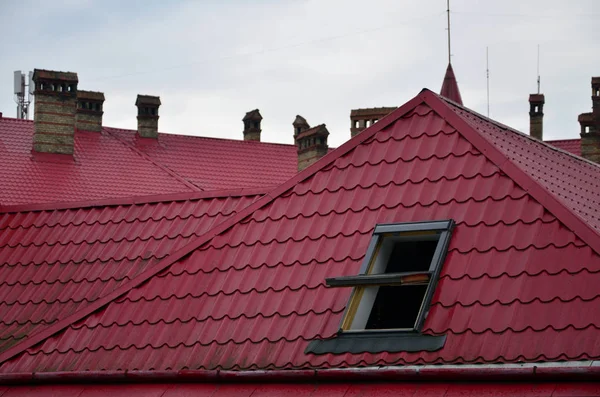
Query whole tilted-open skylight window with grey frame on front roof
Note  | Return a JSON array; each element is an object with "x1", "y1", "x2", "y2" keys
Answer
[{"x1": 327, "y1": 220, "x2": 453, "y2": 332}]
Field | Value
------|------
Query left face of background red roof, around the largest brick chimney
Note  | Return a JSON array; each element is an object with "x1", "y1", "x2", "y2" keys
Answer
[{"x1": 0, "y1": 117, "x2": 200, "y2": 205}]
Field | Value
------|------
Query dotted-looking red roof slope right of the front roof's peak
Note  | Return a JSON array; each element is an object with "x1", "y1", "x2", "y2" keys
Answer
[{"x1": 449, "y1": 104, "x2": 600, "y2": 233}]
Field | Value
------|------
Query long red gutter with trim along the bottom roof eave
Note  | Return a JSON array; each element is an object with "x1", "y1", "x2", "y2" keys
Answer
[{"x1": 0, "y1": 361, "x2": 600, "y2": 385}]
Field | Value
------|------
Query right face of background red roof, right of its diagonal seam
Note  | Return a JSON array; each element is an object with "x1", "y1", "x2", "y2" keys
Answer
[{"x1": 104, "y1": 128, "x2": 298, "y2": 190}]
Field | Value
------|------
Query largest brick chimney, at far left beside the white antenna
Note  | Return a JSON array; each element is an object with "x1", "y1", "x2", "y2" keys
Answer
[{"x1": 33, "y1": 69, "x2": 79, "y2": 154}]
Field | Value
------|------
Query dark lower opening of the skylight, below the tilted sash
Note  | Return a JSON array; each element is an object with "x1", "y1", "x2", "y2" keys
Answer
[{"x1": 365, "y1": 285, "x2": 427, "y2": 329}]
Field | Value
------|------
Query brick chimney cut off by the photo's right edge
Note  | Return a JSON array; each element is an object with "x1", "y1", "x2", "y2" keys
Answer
[{"x1": 577, "y1": 77, "x2": 600, "y2": 163}]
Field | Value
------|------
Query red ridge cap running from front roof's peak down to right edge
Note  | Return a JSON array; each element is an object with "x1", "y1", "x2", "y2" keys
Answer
[{"x1": 424, "y1": 90, "x2": 600, "y2": 254}]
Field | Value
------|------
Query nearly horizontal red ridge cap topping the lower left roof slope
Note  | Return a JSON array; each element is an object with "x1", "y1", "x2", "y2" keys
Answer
[{"x1": 0, "y1": 186, "x2": 276, "y2": 214}]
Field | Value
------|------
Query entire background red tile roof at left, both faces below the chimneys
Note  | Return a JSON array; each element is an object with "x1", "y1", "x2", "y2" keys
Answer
[{"x1": 0, "y1": 117, "x2": 297, "y2": 206}]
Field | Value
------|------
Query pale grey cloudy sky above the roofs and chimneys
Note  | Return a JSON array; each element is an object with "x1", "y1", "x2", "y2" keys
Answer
[{"x1": 0, "y1": 0, "x2": 600, "y2": 146}]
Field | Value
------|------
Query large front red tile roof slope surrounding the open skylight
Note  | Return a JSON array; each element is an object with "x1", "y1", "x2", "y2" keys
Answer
[{"x1": 0, "y1": 91, "x2": 600, "y2": 372}]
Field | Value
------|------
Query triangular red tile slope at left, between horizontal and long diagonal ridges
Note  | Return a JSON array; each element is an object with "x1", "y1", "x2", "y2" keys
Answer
[{"x1": 0, "y1": 189, "x2": 256, "y2": 353}]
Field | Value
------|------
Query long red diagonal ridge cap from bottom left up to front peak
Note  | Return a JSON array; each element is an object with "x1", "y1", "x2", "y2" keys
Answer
[{"x1": 0, "y1": 91, "x2": 425, "y2": 364}]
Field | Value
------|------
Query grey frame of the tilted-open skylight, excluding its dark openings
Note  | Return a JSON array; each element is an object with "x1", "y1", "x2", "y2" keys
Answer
[{"x1": 326, "y1": 219, "x2": 454, "y2": 333}]
